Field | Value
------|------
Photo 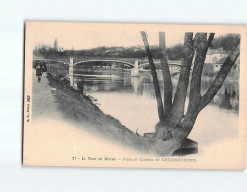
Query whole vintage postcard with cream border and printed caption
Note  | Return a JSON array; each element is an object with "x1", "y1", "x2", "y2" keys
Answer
[{"x1": 23, "y1": 22, "x2": 247, "y2": 169}]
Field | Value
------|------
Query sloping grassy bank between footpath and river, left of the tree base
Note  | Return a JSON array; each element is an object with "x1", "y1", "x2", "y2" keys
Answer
[{"x1": 47, "y1": 73, "x2": 153, "y2": 153}]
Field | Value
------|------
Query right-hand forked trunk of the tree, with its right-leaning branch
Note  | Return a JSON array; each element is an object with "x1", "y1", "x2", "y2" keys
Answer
[{"x1": 172, "y1": 37, "x2": 240, "y2": 138}]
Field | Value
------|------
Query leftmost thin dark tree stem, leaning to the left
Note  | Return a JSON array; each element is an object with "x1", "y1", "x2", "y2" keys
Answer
[{"x1": 141, "y1": 31, "x2": 165, "y2": 121}]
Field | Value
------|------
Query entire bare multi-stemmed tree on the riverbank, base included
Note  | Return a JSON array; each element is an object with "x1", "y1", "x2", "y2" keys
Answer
[{"x1": 141, "y1": 32, "x2": 240, "y2": 155}]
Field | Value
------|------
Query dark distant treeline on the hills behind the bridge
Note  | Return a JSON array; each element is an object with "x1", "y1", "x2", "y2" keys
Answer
[{"x1": 33, "y1": 34, "x2": 240, "y2": 60}]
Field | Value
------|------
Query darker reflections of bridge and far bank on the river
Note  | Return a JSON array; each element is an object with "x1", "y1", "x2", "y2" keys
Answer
[{"x1": 71, "y1": 71, "x2": 239, "y2": 112}]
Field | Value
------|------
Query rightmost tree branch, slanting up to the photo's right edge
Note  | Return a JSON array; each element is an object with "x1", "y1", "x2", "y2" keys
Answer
[{"x1": 199, "y1": 45, "x2": 240, "y2": 110}]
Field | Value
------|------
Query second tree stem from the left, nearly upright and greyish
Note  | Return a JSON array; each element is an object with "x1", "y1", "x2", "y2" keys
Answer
[{"x1": 159, "y1": 32, "x2": 172, "y2": 118}]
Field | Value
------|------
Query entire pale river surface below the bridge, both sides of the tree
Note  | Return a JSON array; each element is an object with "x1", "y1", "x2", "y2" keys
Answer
[{"x1": 70, "y1": 70, "x2": 239, "y2": 144}]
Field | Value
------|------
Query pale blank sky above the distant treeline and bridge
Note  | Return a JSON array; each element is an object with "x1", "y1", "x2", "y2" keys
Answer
[{"x1": 34, "y1": 31, "x2": 184, "y2": 50}]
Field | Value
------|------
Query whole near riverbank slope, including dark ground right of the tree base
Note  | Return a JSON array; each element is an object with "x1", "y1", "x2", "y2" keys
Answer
[{"x1": 47, "y1": 73, "x2": 197, "y2": 156}]
